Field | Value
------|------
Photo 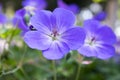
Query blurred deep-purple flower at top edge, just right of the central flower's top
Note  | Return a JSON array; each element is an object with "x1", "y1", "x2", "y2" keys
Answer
[{"x1": 57, "y1": 0, "x2": 79, "y2": 14}]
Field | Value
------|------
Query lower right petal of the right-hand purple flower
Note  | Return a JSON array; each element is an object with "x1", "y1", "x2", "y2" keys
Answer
[{"x1": 96, "y1": 44, "x2": 115, "y2": 59}]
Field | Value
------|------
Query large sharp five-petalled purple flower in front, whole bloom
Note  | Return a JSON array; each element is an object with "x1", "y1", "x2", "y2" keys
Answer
[{"x1": 24, "y1": 8, "x2": 85, "y2": 60}]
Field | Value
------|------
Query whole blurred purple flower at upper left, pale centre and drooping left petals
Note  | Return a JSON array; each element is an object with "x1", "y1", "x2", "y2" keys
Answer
[{"x1": 13, "y1": 0, "x2": 46, "y2": 30}]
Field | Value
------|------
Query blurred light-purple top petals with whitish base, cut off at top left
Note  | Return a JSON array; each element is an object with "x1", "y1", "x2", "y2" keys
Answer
[{"x1": 22, "y1": 0, "x2": 47, "y2": 13}]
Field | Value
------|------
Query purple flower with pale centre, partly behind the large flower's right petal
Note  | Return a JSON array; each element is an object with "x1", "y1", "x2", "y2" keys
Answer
[{"x1": 78, "y1": 20, "x2": 116, "y2": 59}]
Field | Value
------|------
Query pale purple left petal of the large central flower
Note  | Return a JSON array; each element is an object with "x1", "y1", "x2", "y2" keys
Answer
[{"x1": 24, "y1": 31, "x2": 52, "y2": 50}]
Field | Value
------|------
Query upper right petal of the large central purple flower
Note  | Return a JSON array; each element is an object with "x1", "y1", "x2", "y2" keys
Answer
[{"x1": 53, "y1": 8, "x2": 75, "y2": 33}]
